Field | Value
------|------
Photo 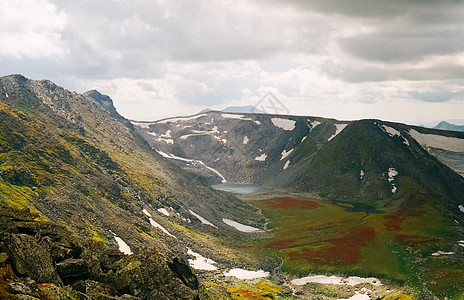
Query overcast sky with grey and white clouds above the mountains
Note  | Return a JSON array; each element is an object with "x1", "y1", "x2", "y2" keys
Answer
[{"x1": 0, "y1": 0, "x2": 464, "y2": 124}]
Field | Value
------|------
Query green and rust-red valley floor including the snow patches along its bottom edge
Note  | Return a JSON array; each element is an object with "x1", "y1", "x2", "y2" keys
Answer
[{"x1": 200, "y1": 190, "x2": 464, "y2": 300}]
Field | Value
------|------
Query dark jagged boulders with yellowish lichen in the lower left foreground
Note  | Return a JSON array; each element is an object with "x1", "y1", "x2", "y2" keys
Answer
[{"x1": 0, "y1": 206, "x2": 199, "y2": 299}]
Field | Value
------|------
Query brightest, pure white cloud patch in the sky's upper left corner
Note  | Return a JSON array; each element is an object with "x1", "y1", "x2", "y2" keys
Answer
[{"x1": 0, "y1": 0, "x2": 67, "y2": 59}]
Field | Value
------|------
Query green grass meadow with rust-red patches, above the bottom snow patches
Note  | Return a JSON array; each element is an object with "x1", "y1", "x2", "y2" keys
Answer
[{"x1": 251, "y1": 192, "x2": 464, "y2": 299}]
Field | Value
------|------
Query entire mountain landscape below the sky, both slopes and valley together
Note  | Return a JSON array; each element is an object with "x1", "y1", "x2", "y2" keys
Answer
[{"x1": 0, "y1": 75, "x2": 464, "y2": 299}]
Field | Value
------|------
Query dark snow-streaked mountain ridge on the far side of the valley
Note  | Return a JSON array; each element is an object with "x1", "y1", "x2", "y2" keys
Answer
[{"x1": 133, "y1": 111, "x2": 464, "y2": 217}]
